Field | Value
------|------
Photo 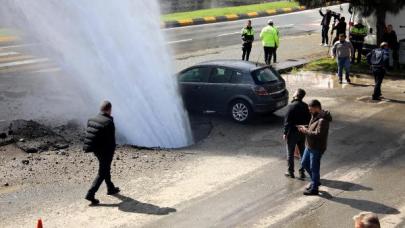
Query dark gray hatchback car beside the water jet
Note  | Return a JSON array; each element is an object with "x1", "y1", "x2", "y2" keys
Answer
[{"x1": 178, "y1": 60, "x2": 288, "y2": 123}]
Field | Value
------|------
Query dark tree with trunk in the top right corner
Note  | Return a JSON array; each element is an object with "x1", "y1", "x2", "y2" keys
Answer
[{"x1": 297, "y1": 0, "x2": 405, "y2": 43}]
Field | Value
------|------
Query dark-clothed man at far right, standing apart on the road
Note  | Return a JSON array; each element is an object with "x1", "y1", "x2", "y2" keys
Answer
[{"x1": 367, "y1": 42, "x2": 390, "y2": 101}]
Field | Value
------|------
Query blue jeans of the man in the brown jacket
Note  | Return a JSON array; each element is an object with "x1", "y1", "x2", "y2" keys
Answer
[{"x1": 301, "y1": 148, "x2": 322, "y2": 191}]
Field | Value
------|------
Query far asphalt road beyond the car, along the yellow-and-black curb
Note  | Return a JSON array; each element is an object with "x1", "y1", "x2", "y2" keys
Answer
[{"x1": 165, "y1": 4, "x2": 350, "y2": 54}]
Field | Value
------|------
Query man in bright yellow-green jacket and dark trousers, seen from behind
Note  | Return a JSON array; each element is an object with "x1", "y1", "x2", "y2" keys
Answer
[{"x1": 260, "y1": 20, "x2": 279, "y2": 65}]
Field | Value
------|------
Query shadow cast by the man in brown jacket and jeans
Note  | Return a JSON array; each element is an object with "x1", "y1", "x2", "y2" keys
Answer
[{"x1": 320, "y1": 191, "x2": 400, "y2": 214}]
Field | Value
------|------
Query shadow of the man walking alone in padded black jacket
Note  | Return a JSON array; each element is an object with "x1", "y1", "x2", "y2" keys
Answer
[{"x1": 97, "y1": 194, "x2": 177, "y2": 215}]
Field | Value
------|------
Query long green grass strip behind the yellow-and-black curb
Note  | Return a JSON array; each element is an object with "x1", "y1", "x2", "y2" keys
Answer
[{"x1": 162, "y1": 1, "x2": 299, "y2": 21}]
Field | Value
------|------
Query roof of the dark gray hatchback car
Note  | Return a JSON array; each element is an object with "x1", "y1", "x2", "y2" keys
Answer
[{"x1": 195, "y1": 60, "x2": 267, "y2": 72}]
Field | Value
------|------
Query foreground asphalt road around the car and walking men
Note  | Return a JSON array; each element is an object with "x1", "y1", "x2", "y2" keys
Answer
[{"x1": 0, "y1": 4, "x2": 405, "y2": 228}]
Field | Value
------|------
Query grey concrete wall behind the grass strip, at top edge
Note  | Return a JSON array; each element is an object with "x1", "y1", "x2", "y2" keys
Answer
[{"x1": 159, "y1": 0, "x2": 276, "y2": 13}]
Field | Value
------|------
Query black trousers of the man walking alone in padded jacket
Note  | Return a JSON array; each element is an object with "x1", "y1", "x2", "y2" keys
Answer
[{"x1": 87, "y1": 152, "x2": 115, "y2": 196}]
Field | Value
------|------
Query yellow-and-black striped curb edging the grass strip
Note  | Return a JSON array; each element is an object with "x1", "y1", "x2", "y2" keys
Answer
[{"x1": 162, "y1": 6, "x2": 307, "y2": 28}]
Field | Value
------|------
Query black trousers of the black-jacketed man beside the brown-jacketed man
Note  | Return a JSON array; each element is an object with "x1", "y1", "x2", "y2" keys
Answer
[{"x1": 287, "y1": 132, "x2": 305, "y2": 173}]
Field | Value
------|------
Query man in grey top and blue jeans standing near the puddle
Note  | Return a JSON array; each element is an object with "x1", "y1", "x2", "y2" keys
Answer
[{"x1": 332, "y1": 34, "x2": 354, "y2": 84}]
